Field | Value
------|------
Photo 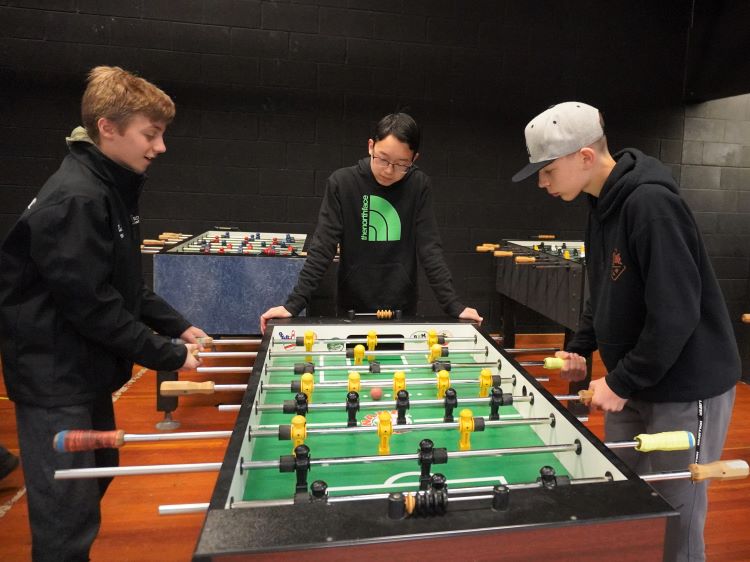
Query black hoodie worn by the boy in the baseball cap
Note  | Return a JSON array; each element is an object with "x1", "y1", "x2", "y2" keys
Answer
[{"x1": 568, "y1": 148, "x2": 741, "y2": 402}]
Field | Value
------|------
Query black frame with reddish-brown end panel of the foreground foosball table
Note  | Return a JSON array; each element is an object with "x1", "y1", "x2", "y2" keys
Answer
[{"x1": 193, "y1": 318, "x2": 679, "y2": 562}]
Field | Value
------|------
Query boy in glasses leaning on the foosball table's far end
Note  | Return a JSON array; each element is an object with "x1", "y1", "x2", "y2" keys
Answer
[{"x1": 260, "y1": 113, "x2": 482, "y2": 332}]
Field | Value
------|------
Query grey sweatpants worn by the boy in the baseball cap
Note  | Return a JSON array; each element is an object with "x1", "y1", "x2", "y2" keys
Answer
[{"x1": 604, "y1": 387, "x2": 735, "y2": 561}]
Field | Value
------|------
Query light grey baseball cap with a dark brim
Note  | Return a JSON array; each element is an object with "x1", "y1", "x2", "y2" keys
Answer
[{"x1": 513, "y1": 101, "x2": 604, "y2": 182}]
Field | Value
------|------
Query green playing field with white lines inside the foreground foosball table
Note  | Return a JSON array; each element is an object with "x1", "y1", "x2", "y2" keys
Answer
[{"x1": 243, "y1": 351, "x2": 568, "y2": 500}]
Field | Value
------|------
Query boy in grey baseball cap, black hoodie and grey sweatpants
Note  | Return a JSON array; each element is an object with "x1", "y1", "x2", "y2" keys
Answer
[{"x1": 513, "y1": 102, "x2": 741, "y2": 560}]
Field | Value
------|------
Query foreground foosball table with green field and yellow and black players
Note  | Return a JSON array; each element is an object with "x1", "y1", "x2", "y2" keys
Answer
[{"x1": 194, "y1": 318, "x2": 677, "y2": 560}]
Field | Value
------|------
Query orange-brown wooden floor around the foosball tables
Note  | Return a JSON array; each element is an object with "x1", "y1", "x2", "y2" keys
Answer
[{"x1": 0, "y1": 336, "x2": 750, "y2": 562}]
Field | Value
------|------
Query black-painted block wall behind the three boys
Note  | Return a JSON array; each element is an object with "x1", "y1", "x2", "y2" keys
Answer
[{"x1": 0, "y1": 0, "x2": 748, "y2": 372}]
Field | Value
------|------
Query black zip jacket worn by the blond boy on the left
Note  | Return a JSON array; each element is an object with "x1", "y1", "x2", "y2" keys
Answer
[{"x1": 0, "y1": 138, "x2": 190, "y2": 407}]
